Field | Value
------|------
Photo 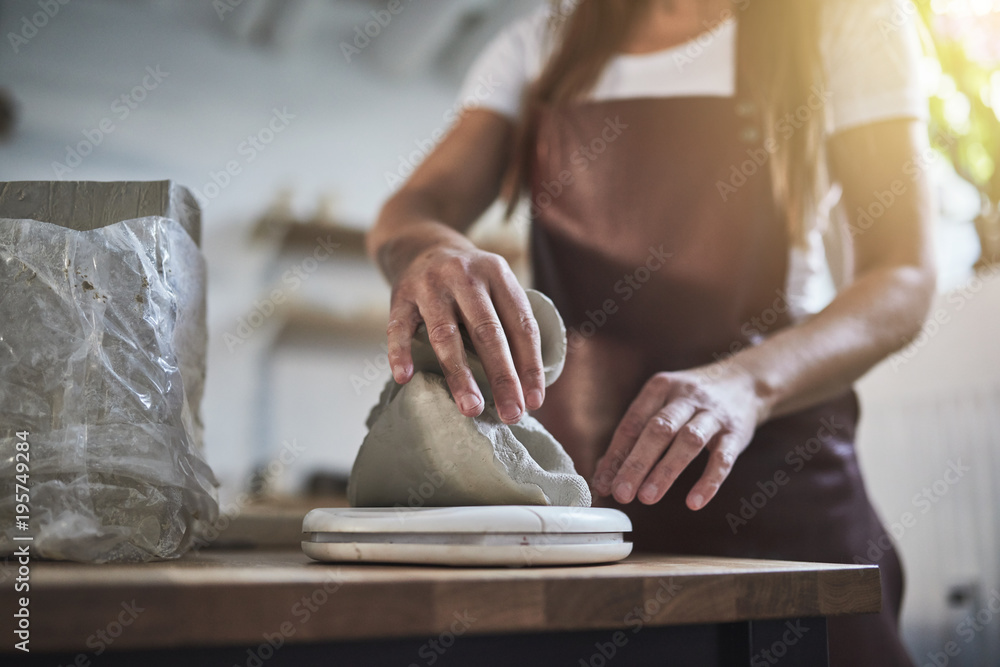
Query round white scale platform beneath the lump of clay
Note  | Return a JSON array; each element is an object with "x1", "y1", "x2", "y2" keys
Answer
[{"x1": 302, "y1": 505, "x2": 632, "y2": 567}]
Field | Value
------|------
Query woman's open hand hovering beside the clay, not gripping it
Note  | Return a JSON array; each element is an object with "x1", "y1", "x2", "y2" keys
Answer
[{"x1": 594, "y1": 364, "x2": 766, "y2": 510}]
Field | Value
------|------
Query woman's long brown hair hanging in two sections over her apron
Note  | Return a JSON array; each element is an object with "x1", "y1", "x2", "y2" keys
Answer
[{"x1": 506, "y1": 0, "x2": 824, "y2": 243}]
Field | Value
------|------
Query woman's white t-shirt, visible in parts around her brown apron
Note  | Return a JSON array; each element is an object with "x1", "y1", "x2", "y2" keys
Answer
[{"x1": 459, "y1": 0, "x2": 928, "y2": 317}]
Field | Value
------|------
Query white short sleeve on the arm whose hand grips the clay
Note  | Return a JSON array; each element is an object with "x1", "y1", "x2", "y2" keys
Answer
[{"x1": 458, "y1": 8, "x2": 548, "y2": 119}]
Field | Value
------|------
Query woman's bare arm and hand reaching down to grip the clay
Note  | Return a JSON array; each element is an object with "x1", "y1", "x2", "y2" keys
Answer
[{"x1": 366, "y1": 108, "x2": 532, "y2": 423}]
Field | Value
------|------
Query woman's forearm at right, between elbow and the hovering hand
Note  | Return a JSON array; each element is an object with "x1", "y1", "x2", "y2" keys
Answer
[{"x1": 730, "y1": 265, "x2": 934, "y2": 423}]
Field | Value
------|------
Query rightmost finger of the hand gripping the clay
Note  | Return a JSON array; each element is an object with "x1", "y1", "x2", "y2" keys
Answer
[{"x1": 490, "y1": 271, "x2": 545, "y2": 410}]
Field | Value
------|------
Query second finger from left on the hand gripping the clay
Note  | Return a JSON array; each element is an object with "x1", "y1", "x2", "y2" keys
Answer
[{"x1": 421, "y1": 300, "x2": 485, "y2": 417}]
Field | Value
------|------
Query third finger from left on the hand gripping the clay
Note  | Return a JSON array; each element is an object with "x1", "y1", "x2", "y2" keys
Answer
[{"x1": 456, "y1": 289, "x2": 524, "y2": 424}]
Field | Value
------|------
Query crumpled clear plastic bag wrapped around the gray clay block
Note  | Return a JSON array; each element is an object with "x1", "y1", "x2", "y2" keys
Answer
[{"x1": 0, "y1": 217, "x2": 218, "y2": 562}]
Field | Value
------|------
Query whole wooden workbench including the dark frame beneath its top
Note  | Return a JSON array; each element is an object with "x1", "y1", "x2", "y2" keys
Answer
[{"x1": 0, "y1": 550, "x2": 881, "y2": 667}]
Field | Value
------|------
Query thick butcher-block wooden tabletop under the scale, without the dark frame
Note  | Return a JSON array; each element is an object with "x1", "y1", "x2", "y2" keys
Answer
[{"x1": 0, "y1": 549, "x2": 881, "y2": 652}]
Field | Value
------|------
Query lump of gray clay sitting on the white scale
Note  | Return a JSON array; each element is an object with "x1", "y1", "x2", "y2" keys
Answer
[{"x1": 347, "y1": 290, "x2": 591, "y2": 508}]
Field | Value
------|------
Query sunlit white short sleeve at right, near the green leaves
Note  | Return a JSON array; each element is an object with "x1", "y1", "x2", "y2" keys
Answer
[{"x1": 820, "y1": 0, "x2": 929, "y2": 134}]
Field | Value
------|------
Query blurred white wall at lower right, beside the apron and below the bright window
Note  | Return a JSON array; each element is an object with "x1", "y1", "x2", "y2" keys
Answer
[{"x1": 858, "y1": 269, "x2": 1000, "y2": 666}]
